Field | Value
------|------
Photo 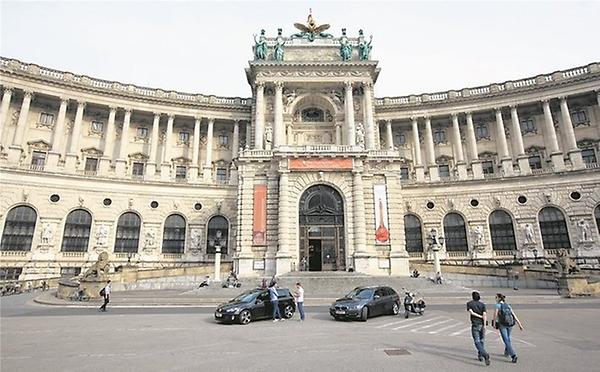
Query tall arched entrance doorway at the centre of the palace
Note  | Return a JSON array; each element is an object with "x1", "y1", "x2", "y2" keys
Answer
[{"x1": 299, "y1": 185, "x2": 346, "y2": 271}]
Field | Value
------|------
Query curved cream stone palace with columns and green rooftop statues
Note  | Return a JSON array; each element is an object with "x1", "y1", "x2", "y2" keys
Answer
[{"x1": 0, "y1": 17, "x2": 600, "y2": 279}]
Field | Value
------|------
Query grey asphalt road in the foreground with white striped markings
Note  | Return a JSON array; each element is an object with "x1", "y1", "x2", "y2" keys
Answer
[{"x1": 0, "y1": 294, "x2": 600, "y2": 372}]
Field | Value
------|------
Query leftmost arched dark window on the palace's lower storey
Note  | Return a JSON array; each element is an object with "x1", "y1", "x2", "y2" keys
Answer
[{"x1": 0, "y1": 206, "x2": 37, "y2": 251}]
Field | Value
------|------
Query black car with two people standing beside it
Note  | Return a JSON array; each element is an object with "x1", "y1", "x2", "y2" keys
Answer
[{"x1": 215, "y1": 288, "x2": 296, "y2": 324}]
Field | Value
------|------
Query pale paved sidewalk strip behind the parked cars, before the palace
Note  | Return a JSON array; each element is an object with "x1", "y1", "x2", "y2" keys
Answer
[{"x1": 33, "y1": 287, "x2": 600, "y2": 308}]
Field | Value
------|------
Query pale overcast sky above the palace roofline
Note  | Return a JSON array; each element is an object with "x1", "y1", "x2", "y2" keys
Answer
[{"x1": 0, "y1": 0, "x2": 600, "y2": 97}]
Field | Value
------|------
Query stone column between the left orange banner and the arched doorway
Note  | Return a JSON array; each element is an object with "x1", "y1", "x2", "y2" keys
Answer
[{"x1": 275, "y1": 170, "x2": 292, "y2": 274}]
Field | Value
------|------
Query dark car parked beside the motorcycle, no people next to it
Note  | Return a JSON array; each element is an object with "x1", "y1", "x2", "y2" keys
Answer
[{"x1": 329, "y1": 286, "x2": 400, "y2": 322}]
